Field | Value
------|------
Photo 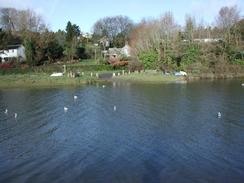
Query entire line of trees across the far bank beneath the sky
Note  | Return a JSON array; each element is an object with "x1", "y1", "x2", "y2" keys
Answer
[{"x1": 0, "y1": 6, "x2": 244, "y2": 72}]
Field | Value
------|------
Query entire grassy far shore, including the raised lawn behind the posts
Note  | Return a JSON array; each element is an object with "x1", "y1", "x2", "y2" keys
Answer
[{"x1": 0, "y1": 60, "x2": 244, "y2": 88}]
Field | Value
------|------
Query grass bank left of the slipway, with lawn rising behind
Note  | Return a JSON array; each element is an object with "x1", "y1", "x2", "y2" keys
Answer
[{"x1": 0, "y1": 60, "x2": 112, "y2": 88}]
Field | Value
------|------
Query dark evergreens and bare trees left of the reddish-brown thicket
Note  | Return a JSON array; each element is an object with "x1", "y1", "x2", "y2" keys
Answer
[{"x1": 0, "y1": 8, "x2": 133, "y2": 66}]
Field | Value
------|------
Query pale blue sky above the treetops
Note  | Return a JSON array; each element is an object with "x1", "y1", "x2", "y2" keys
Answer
[{"x1": 0, "y1": 0, "x2": 244, "y2": 32}]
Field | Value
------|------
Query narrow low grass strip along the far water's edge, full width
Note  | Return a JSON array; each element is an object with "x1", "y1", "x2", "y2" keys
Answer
[{"x1": 0, "y1": 71, "x2": 244, "y2": 88}]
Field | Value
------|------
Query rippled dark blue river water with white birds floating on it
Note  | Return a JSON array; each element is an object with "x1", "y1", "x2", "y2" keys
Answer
[{"x1": 0, "y1": 81, "x2": 244, "y2": 183}]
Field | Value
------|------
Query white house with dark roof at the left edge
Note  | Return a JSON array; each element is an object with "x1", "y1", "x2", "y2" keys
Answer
[{"x1": 0, "y1": 44, "x2": 26, "y2": 63}]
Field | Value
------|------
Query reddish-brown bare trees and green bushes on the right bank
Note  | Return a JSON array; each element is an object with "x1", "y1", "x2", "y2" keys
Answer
[{"x1": 130, "y1": 6, "x2": 244, "y2": 72}]
